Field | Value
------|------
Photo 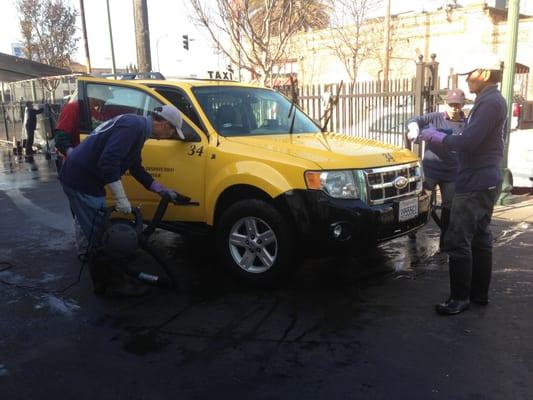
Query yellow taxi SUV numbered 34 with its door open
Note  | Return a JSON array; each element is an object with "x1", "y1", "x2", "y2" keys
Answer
[{"x1": 78, "y1": 77, "x2": 430, "y2": 284}]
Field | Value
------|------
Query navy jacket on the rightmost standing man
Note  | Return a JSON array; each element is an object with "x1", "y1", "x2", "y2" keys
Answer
[{"x1": 444, "y1": 85, "x2": 507, "y2": 193}]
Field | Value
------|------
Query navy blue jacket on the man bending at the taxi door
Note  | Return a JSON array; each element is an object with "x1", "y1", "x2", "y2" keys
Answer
[{"x1": 59, "y1": 114, "x2": 154, "y2": 196}]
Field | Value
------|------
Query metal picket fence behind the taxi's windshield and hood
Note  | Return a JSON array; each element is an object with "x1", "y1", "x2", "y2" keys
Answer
[{"x1": 278, "y1": 57, "x2": 442, "y2": 155}]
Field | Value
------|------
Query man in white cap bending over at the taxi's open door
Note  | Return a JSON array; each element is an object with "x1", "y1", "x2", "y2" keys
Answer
[{"x1": 59, "y1": 105, "x2": 184, "y2": 296}]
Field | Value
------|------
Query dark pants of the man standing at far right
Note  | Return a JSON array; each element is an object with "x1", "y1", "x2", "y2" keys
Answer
[{"x1": 444, "y1": 188, "x2": 499, "y2": 300}]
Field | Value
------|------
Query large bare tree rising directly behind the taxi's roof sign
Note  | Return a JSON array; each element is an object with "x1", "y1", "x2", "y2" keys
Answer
[{"x1": 190, "y1": 0, "x2": 329, "y2": 86}]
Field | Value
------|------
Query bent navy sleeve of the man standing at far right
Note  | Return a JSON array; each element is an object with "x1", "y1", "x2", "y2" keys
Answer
[{"x1": 443, "y1": 101, "x2": 501, "y2": 152}]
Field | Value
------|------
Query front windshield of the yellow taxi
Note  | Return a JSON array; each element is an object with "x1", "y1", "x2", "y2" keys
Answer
[{"x1": 193, "y1": 86, "x2": 320, "y2": 136}]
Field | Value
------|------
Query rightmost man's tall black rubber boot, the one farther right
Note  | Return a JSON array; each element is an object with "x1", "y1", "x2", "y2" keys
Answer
[{"x1": 470, "y1": 248, "x2": 492, "y2": 306}]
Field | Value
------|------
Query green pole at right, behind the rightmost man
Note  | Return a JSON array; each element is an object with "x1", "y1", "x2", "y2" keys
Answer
[{"x1": 498, "y1": 0, "x2": 520, "y2": 204}]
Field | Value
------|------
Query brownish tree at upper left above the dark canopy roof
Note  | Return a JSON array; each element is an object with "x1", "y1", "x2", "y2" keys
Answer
[{"x1": 17, "y1": 0, "x2": 79, "y2": 67}]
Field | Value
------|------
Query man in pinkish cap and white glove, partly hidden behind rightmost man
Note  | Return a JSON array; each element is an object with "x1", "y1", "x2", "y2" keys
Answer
[{"x1": 407, "y1": 89, "x2": 466, "y2": 248}]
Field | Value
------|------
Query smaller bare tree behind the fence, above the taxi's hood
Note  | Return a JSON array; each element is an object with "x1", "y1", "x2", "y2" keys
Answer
[{"x1": 330, "y1": 0, "x2": 383, "y2": 87}]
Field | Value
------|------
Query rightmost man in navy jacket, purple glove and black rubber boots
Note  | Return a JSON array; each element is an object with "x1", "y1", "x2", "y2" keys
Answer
[{"x1": 420, "y1": 55, "x2": 507, "y2": 315}]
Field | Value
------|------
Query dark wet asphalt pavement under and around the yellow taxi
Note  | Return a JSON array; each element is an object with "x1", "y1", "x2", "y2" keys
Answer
[{"x1": 0, "y1": 147, "x2": 533, "y2": 400}]
